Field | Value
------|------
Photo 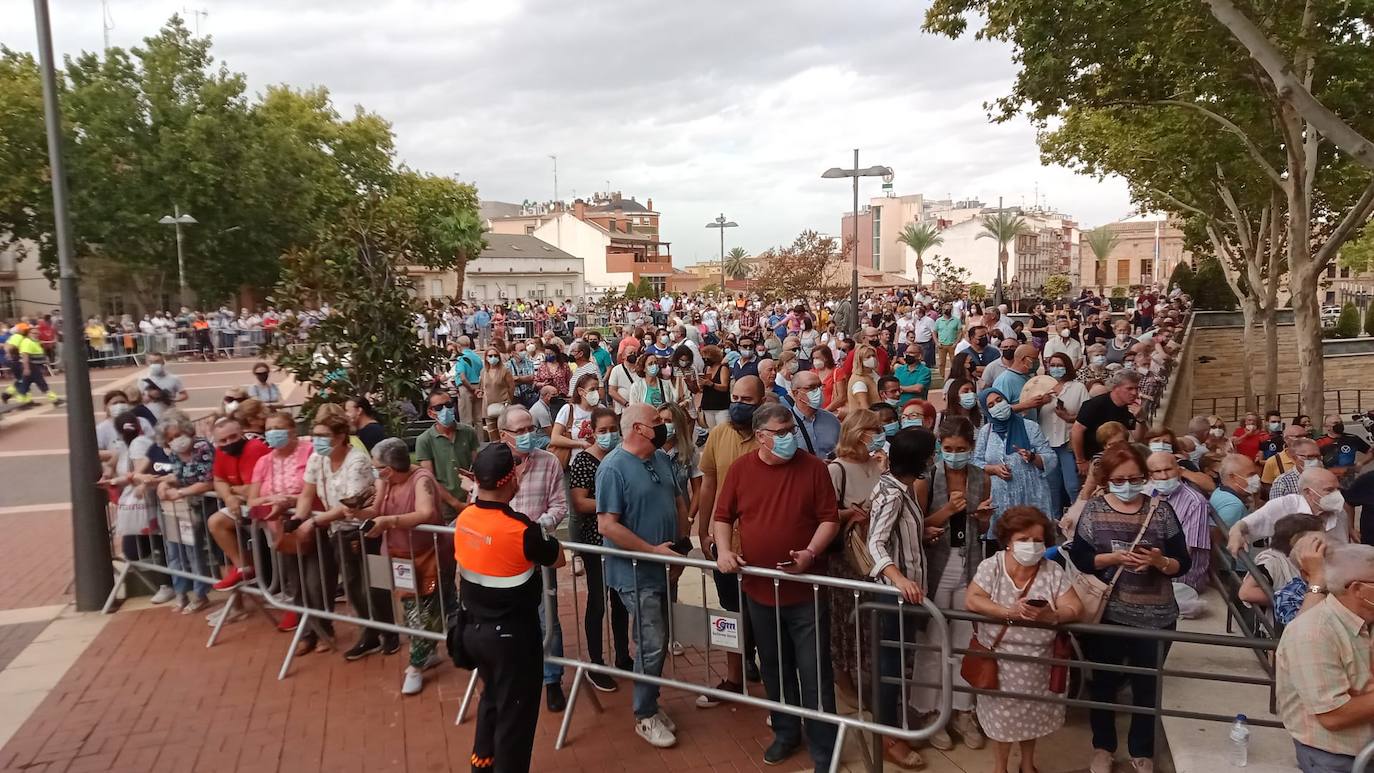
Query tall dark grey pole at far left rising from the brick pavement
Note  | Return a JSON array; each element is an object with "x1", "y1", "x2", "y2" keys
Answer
[{"x1": 33, "y1": 0, "x2": 114, "y2": 612}]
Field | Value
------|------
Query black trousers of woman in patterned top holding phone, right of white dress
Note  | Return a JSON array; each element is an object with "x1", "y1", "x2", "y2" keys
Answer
[{"x1": 1083, "y1": 623, "x2": 1176, "y2": 758}]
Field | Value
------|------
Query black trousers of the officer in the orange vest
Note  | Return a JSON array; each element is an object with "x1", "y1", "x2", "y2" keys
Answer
[{"x1": 463, "y1": 610, "x2": 544, "y2": 773}]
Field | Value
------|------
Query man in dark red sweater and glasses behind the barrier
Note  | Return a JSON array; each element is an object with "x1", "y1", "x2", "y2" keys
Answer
[{"x1": 712, "y1": 404, "x2": 840, "y2": 770}]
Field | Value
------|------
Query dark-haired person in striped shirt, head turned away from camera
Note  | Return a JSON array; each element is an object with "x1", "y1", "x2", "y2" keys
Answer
[{"x1": 867, "y1": 430, "x2": 936, "y2": 770}]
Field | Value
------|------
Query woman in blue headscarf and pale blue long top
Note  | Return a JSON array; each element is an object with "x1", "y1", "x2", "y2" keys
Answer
[{"x1": 973, "y1": 389, "x2": 1057, "y2": 537}]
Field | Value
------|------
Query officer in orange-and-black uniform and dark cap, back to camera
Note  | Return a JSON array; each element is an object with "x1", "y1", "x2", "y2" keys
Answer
[{"x1": 453, "y1": 443, "x2": 562, "y2": 773}]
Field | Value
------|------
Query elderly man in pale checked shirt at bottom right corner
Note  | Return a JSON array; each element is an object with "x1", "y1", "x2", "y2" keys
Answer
[{"x1": 1275, "y1": 545, "x2": 1374, "y2": 773}]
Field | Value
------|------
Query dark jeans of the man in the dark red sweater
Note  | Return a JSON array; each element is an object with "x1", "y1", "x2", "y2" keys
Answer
[{"x1": 747, "y1": 595, "x2": 835, "y2": 770}]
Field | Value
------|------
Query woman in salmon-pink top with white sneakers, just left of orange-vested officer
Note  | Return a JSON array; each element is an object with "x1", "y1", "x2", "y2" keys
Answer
[{"x1": 361, "y1": 439, "x2": 439, "y2": 695}]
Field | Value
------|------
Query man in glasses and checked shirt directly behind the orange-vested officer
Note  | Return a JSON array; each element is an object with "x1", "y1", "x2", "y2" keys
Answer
[{"x1": 496, "y1": 405, "x2": 567, "y2": 713}]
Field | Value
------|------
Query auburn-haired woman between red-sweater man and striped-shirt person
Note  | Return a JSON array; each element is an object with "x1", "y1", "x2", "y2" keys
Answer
[{"x1": 827, "y1": 411, "x2": 888, "y2": 706}]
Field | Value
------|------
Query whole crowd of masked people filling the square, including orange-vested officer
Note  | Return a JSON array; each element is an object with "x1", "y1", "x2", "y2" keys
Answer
[{"x1": 83, "y1": 288, "x2": 1374, "y2": 773}]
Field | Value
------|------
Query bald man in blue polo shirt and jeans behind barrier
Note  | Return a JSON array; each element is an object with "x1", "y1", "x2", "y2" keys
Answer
[{"x1": 596, "y1": 402, "x2": 687, "y2": 748}]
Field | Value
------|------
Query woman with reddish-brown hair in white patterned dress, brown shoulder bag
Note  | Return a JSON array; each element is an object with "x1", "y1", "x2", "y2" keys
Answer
[{"x1": 967, "y1": 507, "x2": 1082, "y2": 773}]
